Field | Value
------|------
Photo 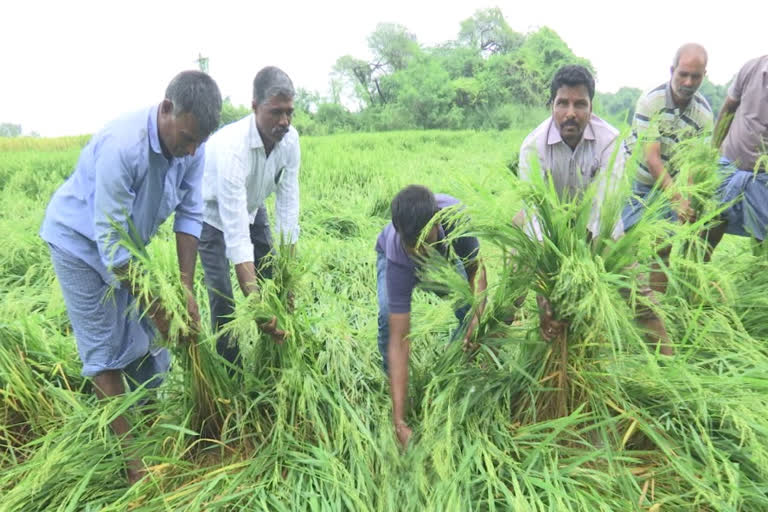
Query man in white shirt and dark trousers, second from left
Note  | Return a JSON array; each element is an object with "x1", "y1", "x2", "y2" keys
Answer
[{"x1": 199, "y1": 66, "x2": 301, "y2": 365}]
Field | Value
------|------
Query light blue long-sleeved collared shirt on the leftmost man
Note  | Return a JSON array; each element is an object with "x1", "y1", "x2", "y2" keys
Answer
[{"x1": 40, "y1": 106, "x2": 205, "y2": 285}]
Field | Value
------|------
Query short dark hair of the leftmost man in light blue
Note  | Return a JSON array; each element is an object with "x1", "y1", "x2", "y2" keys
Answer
[{"x1": 165, "y1": 71, "x2": 221, "y2": 138}]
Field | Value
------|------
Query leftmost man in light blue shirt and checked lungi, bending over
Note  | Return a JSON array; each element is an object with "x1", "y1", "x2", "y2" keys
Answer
[{"x1": 40, "y1": 71, "x2": 221, "y2": 482}]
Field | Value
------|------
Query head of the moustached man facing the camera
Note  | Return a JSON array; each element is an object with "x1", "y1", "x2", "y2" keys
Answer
[{"x1": 549, "y1": 66, "x2": 595, "y2": 148}]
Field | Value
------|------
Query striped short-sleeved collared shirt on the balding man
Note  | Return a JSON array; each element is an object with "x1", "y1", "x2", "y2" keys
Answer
[{"x1": 624, "y1": 82, "x2": 713, "y2": 185}]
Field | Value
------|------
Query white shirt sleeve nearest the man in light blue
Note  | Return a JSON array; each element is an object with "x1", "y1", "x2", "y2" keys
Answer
[{"x1": 217, "y1": 153, "x2": 253, "y2": 265}]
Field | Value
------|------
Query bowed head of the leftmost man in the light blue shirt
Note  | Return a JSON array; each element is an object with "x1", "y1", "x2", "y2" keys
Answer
[{"x1": 157, "y1": 71, "x2": 221, "y2": 157}]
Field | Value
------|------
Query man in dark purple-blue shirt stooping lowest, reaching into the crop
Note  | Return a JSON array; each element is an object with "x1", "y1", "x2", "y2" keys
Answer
[{"x1": 376, "y1": 185, "x2": 487, "y2": 446}]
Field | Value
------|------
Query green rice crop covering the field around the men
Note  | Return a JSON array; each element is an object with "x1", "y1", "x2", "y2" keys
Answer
[{"x1": 0, "y1": 131, "x2": 768, "y2": 511}]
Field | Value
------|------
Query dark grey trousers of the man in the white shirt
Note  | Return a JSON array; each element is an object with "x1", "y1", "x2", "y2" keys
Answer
[{"x1": 198, "y1": 208, "x2": 272, "y2": 366}]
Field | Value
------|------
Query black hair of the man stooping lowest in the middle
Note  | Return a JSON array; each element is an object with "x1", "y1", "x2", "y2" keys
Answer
[{"x1": 390, "y1": 185, "x2": 438, "y2": 247}]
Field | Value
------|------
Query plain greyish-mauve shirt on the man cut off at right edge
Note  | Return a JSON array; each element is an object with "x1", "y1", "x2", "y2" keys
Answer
[{"x1": 720, "y1": 55, "x2": 768, "y2": 171}]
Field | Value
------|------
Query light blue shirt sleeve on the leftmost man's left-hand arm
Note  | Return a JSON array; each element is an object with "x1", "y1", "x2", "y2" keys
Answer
[{"x1": 93, "y1": 136, "x2": 136, "y2": 269}]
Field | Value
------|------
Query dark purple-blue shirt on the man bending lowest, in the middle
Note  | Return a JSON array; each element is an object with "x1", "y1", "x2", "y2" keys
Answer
[{"x1": 376, "y1": 194, "x2": 480, "y2": 313}]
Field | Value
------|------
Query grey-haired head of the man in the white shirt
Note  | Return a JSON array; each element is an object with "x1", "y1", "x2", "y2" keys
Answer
[{"x1": 252, "y1": 66, "x2": 296, "y2": 147}]
